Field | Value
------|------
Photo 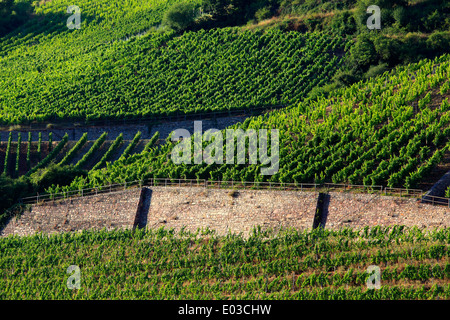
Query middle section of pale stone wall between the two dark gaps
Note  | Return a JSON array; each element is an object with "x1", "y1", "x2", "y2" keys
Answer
[{"x1": 147, "y1": 187, "x2": 318, "y2": 235}]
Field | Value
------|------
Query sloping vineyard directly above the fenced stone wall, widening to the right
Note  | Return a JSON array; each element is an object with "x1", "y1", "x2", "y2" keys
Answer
[{"x1": 56, "y1": 55, "x2": 450, "y2": 190}]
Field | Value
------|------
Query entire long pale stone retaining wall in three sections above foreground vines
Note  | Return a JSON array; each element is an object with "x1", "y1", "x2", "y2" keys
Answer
[{"x1": 0, "y1": 186, "x2": 450, "y2": 236}]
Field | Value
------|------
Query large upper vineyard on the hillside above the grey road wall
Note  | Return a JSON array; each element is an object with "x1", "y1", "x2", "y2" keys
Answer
[{"x1": 0, "y1": 1, "x2": 351, "y2": 124}]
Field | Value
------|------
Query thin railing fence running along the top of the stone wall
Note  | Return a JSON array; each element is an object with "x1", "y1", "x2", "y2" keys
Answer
[{"x1": 21, "y1": 178, "x2": 450, "y2": 207}]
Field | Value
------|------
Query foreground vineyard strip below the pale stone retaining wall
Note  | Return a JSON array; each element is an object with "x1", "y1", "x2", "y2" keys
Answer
[{"x1": 0, "y1": 226, "x2": 450, "y2": 300}]
